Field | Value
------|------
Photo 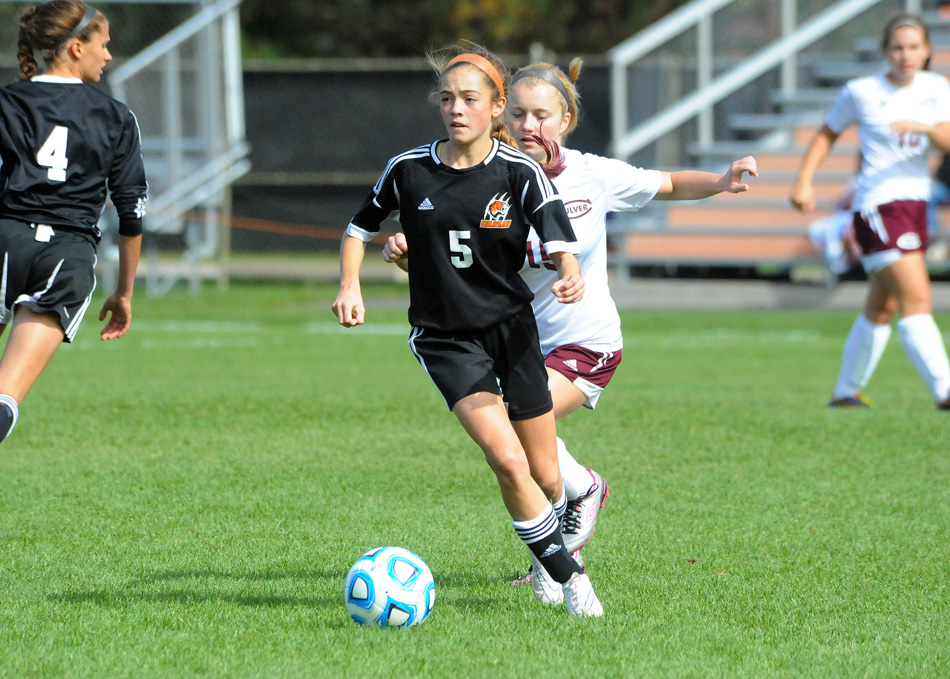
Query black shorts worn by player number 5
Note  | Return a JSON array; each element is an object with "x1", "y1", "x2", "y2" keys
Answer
[{"x1": 409, "y1": 306, "x2": 554, "y2": 420}]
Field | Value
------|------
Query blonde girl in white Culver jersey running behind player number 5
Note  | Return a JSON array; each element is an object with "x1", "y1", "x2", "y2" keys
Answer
[{"x1": 383, "y1": 59, "x2": 757, "y2": 598}]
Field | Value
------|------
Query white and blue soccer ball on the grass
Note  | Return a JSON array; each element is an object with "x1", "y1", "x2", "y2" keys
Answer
[{"x1": 343, "y1": 547, "x2": 435, "y2": 627}]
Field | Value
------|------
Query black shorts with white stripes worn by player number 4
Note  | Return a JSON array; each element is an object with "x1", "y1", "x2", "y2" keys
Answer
[{"x1": 0, "y1": 219, "x2": 96, "y2": 342}]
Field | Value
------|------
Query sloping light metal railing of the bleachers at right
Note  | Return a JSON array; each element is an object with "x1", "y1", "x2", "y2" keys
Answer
[{"x1": 608, "y1": 0, "x2": 921, "y2": 159}]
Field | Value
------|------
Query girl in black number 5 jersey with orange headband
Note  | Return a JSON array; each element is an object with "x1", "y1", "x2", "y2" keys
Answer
[{"x1": 333, "y1": 48, "x2": 603, "y2": 616}]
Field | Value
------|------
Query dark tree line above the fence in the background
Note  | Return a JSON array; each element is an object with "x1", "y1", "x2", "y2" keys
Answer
[{"x1": 235, "y1": 0, "x2": 686, "y2": 58}]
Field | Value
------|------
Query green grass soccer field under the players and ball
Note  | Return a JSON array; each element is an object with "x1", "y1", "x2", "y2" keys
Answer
[{"x1": 0, "y1": 286, "x2": 950, "y2": 679}]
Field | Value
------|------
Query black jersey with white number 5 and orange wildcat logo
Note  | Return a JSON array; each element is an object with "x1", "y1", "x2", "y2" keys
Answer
[{"x1": 347, "y1": 140, "x2": 577, "y2": 330}]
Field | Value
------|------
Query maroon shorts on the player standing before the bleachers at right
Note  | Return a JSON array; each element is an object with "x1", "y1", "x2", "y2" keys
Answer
[{"x1": 854, "y1": 200, "x2": 928, "y2": 255}]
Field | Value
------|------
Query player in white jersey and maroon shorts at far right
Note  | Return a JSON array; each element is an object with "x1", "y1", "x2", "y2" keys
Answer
[{"x1": 790, "y1": 14, "x2": 950, "y2": 409}]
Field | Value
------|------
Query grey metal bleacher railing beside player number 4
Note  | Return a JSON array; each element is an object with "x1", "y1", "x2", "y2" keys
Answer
[{"x1": 102, "y1": 0, "x2": 250, "y2": 295}]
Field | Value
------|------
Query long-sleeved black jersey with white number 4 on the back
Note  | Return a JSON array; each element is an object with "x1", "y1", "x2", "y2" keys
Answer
[{"x1": 0, "y1": 76, "x2": 148, "y2": 236}]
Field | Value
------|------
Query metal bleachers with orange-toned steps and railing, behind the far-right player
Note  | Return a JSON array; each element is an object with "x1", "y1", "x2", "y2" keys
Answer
[{"x1": 609, "y1": 0, "x2": 950, "y2": 278}]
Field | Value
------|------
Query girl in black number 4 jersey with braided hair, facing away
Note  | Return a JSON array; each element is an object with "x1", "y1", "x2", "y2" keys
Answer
[{"x1": 0, "y1": 0, "x2": 147, "y2": 440}]
